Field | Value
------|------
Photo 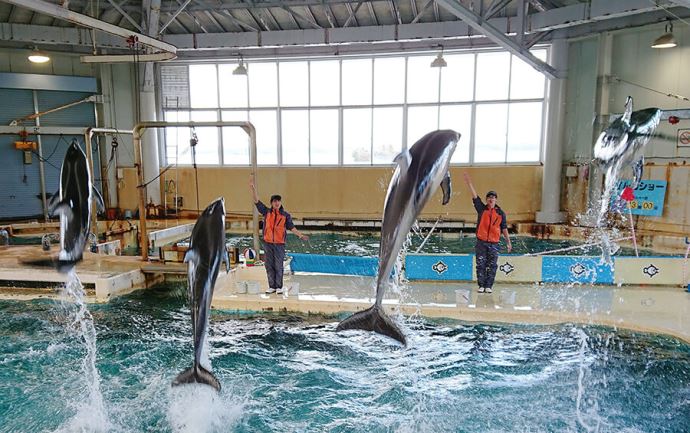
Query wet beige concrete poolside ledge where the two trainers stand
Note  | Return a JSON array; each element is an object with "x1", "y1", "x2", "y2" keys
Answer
[{"x1": 213, "y1": 268, "x2": 690, "y2": 343}]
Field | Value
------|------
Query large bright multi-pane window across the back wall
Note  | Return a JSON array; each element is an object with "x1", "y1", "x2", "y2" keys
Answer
[{"x1": 161, "y1": 48, "x2": 547, "y2": 166}]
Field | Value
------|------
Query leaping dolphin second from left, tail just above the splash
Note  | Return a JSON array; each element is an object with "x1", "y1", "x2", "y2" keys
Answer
[{"x1": 172, "y1": 198, "x2": 230, "y2": 391}]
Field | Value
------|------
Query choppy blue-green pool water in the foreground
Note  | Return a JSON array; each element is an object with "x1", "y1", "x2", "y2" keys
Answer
[{"x1": 0, "y1": 287, "x2": 690, "y2": 432}]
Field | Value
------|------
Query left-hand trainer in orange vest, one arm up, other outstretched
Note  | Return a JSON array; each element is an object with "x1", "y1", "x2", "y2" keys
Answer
[{"x1": 249, "y1": 176, "x2": 309, "y2": 294}]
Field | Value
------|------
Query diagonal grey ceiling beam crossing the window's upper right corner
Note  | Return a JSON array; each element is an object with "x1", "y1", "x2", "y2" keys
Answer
[{"x1": 437, "y1": 0, "x2": 558, "y2": 79}]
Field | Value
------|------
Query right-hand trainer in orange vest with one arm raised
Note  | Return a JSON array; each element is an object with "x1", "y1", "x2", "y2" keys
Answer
[{"x1": 463, "y1": 172, "x2": 513, "y2": 293}]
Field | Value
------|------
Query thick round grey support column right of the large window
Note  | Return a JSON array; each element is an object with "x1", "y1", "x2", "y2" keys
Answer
[{"x1": 536, "y1": 39, "x2": 568, "y2": 224}]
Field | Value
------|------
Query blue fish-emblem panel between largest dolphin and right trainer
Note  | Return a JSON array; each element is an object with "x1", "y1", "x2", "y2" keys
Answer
[{"x1": 405, "y1": 254, "x2": 473, "y2": 281}]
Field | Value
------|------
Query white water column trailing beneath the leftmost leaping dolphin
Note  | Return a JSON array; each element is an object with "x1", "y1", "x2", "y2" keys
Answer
[{"x1": 53, "y1": 270, "x2": 111, "y2": 432}]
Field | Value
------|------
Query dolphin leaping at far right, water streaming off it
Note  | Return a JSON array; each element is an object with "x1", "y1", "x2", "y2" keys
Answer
[{"x1": 594, "y1": 96, "x2": 661, "y2": 188}]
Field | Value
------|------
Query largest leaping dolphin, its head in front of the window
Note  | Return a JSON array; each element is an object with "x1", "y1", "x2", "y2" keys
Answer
[{"x1": 336, "y1": 130, "x2": 460, "y2": 345}]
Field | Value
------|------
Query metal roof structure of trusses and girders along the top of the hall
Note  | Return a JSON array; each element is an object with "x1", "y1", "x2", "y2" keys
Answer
[{"x1": 0, "y1": 0, "x2": 690, "y2": 61}]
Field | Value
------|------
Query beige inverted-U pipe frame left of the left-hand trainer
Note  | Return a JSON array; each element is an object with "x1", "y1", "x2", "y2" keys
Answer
[{"x1": 132, "y1": 120, "x2": 259, "y2": 261}]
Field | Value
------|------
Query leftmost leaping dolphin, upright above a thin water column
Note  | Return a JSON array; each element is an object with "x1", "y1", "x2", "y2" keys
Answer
[{"x1": 43, "y1": 140, "x2": 103, "y2": 273}]
